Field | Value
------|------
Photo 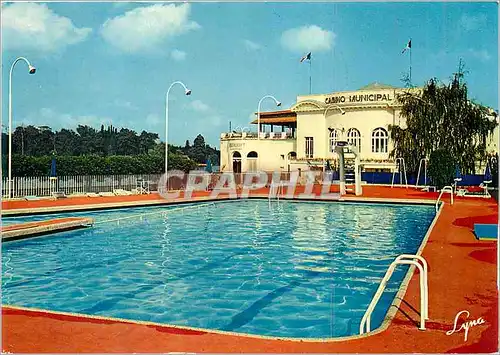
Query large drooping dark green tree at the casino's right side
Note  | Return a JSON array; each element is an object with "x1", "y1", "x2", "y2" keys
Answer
[{"x1": 389, "y1": 62, "x2": 497, "y2": 178}]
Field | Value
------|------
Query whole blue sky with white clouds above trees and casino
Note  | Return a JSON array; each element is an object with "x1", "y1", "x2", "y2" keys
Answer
[{"x1": 2, "y1": 2, "x2": 498, "y2": 146}]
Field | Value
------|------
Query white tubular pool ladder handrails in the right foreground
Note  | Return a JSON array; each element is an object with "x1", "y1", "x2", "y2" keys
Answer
[{"x1": 359, "y1": 254, "x2": 429, "y2": 334}]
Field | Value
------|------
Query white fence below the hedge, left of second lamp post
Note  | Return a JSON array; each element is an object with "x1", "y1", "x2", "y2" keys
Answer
[{"x1": 2, "y1": 174, "x2": 161, "y2": 198}]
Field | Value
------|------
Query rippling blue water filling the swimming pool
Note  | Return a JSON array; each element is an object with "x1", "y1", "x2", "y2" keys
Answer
[{"x1": 2, "y1": 200, "x2": 435, "y2": 338}]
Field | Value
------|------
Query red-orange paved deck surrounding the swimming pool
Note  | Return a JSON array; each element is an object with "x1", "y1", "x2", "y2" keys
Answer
[{"x1": 2, "y1": 186, "x2": 498, "y2": 353}]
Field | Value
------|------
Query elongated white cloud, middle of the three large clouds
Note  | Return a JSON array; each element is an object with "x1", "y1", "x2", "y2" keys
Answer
[{"x1": 101, "y1": 4, "x2": 201, "y2": 53}]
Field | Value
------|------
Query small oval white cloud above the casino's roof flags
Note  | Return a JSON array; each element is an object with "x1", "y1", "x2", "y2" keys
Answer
[{"x1": 281, "y1": 25, "x2": 336, "y2": 53}]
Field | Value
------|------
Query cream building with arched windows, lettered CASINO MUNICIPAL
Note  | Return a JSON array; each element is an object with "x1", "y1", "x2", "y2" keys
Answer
[{"x1": 220, "y1": 83, "x2": 498, "y2": 173}]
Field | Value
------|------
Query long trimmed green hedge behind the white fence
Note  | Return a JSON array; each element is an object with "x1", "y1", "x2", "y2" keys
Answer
[{"x1": 2, "y1": 154, "x2": 197, "y2": 177}]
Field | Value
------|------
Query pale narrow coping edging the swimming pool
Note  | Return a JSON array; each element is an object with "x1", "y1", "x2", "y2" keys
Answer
[{"x1": 1, "y1": 195, "x2": 445, "y2": 343}]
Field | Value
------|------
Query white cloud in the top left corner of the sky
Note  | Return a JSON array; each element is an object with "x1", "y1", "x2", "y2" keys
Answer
[{"x1": 2, "y1": 2, "x2": 92, "y2": 53}]
